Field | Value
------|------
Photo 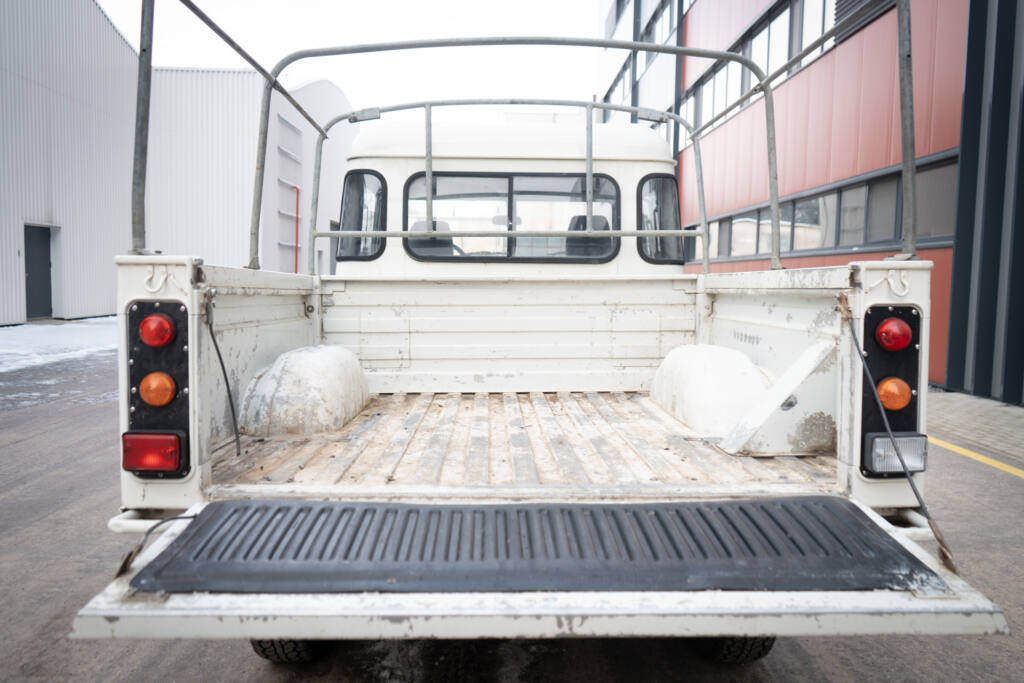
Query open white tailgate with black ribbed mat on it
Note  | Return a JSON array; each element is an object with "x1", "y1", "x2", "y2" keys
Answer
[{"x1": 73, "y1": 496, "x2": 1007, "y2": 639}]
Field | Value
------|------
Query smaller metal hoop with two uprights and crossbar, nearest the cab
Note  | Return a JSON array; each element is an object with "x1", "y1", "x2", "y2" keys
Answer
[{"x1": 299, "y1": 98, "x2": 710, "y2": 273}]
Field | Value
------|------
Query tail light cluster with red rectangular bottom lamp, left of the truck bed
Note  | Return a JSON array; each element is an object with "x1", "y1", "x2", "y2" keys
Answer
[{"x1": 121, "y1": 301, "x2": 190, "y2": 479}]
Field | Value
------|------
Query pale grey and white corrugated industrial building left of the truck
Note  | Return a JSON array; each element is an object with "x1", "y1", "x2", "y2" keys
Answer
[{"x1": 0, "y1": 0, "x2": 352, "y2": 325}]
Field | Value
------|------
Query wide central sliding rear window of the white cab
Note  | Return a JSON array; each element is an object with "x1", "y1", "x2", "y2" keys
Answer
[{"x1": 402, "y1": 173, "x2": 620, "y2": 263}]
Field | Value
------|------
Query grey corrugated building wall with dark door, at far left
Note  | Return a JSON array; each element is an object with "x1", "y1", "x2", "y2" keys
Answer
[{"x1": 0, "y1": 0, "x2": 137, "y2": 324}]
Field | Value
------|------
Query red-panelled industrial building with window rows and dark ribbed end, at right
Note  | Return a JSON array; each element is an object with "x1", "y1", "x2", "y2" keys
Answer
[{"x1": 603, "y1": 0, "x2": 1024, "y2": 403}]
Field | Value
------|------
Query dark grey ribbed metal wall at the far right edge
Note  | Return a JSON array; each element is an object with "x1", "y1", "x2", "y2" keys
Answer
[{"x1": 946, "y1": 0, "x2": 1024, "y2": 403}]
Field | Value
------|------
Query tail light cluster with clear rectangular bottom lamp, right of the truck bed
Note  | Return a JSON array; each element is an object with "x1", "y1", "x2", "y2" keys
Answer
[{"x1": 860, "y1": 306, "x2": 928, "y2": 478}]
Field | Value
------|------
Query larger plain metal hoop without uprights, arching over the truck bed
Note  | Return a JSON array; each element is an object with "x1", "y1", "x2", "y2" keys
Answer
[{"x1": 249, "y1": 37, "x2": 778, "y2": 268}]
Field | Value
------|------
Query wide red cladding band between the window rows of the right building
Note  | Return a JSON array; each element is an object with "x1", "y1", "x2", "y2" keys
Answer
[{"x1": 681, "y1": 0, "x2": 968, "y2": 222}]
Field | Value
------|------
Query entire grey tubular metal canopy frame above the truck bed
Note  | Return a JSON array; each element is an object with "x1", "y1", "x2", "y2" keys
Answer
[{"x1": 132, "y1": 0, "x2": 916, "y2": 273}]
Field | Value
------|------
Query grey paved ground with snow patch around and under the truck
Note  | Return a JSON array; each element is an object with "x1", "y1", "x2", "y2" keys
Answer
[{"x1": 0, "y1": 352, "x2": 1024, "y2": 683}]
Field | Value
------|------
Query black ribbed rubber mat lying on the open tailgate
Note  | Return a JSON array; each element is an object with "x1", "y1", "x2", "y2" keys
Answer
[{"x1": 131, "y1": 496, "x2": 944, "y2": 593}]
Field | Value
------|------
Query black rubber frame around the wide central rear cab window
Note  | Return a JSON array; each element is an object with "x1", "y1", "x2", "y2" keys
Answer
[{"x1": 401, "y1": 171, "x2": 623, "y2": 264}]
